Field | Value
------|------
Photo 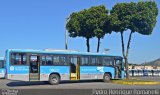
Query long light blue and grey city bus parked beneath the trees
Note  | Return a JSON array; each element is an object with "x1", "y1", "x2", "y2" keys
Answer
[{"x1": 6, "y1": 49, "x2": 124, "y2": 85}]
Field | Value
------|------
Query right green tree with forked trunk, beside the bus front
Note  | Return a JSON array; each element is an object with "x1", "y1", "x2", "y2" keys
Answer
[{"x1": 111, "y1": 1, "x2": 158, "y2": 78}]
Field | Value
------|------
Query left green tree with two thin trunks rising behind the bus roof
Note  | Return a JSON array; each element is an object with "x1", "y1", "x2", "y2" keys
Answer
[{"x1": 66, "y1": 5, "x2": 108, "y2": 52}]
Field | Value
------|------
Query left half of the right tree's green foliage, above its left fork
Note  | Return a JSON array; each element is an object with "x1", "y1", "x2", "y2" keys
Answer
[{"x1": 111, "y1": 2, "x2": 136, "y2": 32}]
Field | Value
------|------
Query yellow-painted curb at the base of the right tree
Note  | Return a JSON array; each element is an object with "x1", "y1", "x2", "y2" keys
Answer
[{"x1": 112, "y1": 81, "x2": 160, "y2": 85}]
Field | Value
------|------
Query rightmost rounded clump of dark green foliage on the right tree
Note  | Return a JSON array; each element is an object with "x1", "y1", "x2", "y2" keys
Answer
[{"x1": 132, "y1": 1, "x2": 158, "y2": 35}]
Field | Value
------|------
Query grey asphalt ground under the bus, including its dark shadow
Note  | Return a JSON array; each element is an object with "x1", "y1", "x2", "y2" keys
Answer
[{"x1": 0, "y1": 77, "x2": 160, "y2": 89}]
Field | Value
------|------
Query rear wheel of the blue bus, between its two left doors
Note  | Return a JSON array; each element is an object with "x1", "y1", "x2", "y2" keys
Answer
[{"x1": 49, "y1": 74, "x2": 60, "y2": 85}]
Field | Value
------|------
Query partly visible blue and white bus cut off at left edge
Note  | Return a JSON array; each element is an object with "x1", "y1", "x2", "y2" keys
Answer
[{"x1": 0, "y1": 57, "x2": 6, "y2": 78}]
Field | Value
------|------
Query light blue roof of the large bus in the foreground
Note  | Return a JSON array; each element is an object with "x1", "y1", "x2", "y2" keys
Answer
[{"x1": 7, "y1": 49, "x2": 122, "y2": 58}]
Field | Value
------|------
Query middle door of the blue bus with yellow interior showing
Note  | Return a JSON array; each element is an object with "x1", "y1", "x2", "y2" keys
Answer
[{"x1": 70, "y1": 57, "x2": 80, "y2": 80}]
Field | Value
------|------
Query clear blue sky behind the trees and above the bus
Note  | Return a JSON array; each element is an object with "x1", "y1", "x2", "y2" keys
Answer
[{"x1": 0, "y1": 0, "x2": 160, "y2": 64}]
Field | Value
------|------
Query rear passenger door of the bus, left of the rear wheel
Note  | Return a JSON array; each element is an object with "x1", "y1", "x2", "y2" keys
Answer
[{"x1": 29, "y1": 55, "x2": 40, "y2": 81}]
